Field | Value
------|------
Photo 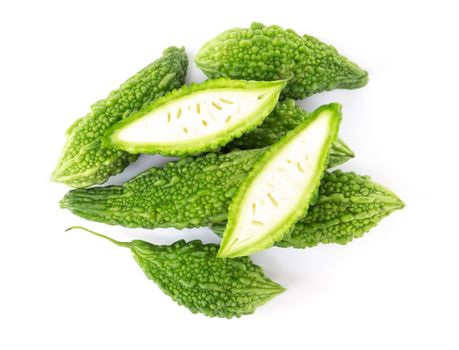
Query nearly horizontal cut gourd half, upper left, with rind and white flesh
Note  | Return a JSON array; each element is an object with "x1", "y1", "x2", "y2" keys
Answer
[{"x1": 104, "y1": 79, "x2": 286, "y2": 155}]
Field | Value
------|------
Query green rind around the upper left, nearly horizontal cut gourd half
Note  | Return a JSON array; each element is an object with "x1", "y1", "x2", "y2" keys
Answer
[{"x1": 103, "y1": 78, "x2": 286, "y2": 156}]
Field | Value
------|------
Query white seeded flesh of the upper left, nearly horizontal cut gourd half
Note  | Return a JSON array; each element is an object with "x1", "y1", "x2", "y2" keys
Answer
[{"x1": 117, "y1": 87, "x2": 276, "y2": 144}]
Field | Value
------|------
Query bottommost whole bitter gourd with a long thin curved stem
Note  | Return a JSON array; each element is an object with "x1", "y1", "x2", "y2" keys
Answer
[{"x1": 67, "y1": 227, "x2": 285, "y2": 318}]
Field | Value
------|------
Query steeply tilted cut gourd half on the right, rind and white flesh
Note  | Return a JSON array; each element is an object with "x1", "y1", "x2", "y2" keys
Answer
[{"x1": 218, "y1": 103, "x2": 341, "y2": 258}]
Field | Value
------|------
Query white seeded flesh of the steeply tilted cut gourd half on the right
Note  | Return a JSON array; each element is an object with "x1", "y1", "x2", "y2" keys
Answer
[{"x1": 228, "y1": 112, "x2": 329, "y2": 250}]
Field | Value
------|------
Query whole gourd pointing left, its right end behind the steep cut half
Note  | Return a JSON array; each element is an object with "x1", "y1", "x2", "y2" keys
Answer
[{"x1": 61, "y1": 149, "x2": 264, "y2": 229}]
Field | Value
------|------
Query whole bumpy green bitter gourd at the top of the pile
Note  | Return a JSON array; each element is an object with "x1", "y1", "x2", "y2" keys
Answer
[{"x1": 195, "y1": 23, "x2": 368, "y2": 99}]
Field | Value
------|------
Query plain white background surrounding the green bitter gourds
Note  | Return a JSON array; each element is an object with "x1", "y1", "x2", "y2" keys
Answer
[{"x1": 0, "y1": 0, "x2": 459, "y2": 350}]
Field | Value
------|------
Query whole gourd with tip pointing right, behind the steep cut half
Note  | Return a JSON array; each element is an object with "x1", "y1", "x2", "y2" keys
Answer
[{"x1": 211, "y1": 170, "x2": 405, "y2": 248}]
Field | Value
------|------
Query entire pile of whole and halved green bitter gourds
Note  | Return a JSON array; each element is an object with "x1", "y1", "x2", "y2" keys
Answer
[{"x1": 52, "y1": 23, "x2": 404, "y2": 318}]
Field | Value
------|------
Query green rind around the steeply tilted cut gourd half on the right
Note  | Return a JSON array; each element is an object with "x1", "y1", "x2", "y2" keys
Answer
[{"x1": 218, "y1": 103, "x2": 341, "y2": 258}]
